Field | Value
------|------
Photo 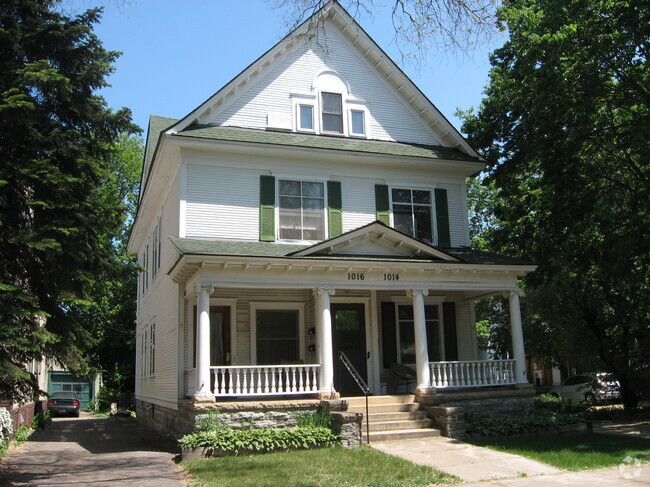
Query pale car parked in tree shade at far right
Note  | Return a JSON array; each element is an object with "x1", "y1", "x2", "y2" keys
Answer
[{"x1": 548, "y1": 373, "x2": 621, "y2": 405}]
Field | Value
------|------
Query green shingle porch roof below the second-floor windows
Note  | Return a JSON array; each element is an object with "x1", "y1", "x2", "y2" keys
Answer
[{"x1": 169, "y1": 237, "x2": 532, "y2": 265}]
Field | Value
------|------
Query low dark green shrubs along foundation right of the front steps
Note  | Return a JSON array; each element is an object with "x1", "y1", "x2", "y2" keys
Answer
[{"x1": 465, "y1": 409, "x2": 584, "y2": 436}]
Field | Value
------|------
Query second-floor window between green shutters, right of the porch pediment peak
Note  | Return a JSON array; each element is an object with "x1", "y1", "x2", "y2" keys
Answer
[{"x1": 391, "y1": 188, "x2": 433, "y2": 246}]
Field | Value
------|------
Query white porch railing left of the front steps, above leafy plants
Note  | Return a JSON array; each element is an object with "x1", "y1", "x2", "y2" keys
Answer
[{"x1": 210, "y1": 364, "x2": 320, "y2": 396}]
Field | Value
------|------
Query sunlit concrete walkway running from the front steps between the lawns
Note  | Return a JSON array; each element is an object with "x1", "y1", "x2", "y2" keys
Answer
[{"x1": 370, "y1": 436, "x2": 563, "y2": 485}]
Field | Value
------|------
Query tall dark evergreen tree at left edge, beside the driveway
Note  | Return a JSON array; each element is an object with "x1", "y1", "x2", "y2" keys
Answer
[{"x1": 0, "y1": 0, "x2": 135, "y2": 397}]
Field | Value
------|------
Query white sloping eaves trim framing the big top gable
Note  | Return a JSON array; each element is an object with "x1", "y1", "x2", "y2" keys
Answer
[{"x1": 166, "y1": 0, "x2": 476, "y2": 161}]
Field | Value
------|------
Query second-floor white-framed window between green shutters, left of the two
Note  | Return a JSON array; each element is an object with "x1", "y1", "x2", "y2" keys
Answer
[{"x1": 278, "y1": 179, "x2": 325, "y2": 240}]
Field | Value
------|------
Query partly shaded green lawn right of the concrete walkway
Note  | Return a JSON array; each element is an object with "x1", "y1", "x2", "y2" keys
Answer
[{"x1": 467, "y1": 433, "x2": 650, "y2": 470}]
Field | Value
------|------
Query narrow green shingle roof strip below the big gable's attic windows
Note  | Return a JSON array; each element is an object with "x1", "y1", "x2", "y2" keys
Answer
[{"x1": 175, "y1": 125, "x2": 479, "y2": 162}]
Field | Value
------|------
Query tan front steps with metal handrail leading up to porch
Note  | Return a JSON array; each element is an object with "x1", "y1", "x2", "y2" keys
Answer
[{"x1": 343, "y1": 394, "x2": 440, "y2": 442}]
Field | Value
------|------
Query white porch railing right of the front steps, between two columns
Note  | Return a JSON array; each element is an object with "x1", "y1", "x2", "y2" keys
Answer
[{"x1": 429, "y1": 359, "x2": 516, "y2": 389}]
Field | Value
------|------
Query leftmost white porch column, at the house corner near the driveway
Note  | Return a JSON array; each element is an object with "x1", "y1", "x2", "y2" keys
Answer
[{"x1": 194, "y1": 284, "x2": 214, "y2": 399}]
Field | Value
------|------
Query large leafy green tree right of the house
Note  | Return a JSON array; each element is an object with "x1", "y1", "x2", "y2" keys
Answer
[{"x1": 463, "y1": 0, "x2": 650, "y2": 407}]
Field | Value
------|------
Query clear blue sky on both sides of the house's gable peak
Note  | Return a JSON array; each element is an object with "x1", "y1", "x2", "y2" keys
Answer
[{"x1": 68, "y1": 0, "x2": 494, "y2": 135}]
